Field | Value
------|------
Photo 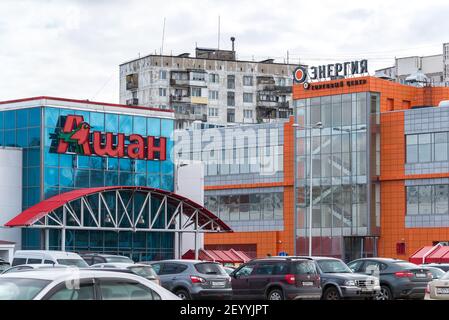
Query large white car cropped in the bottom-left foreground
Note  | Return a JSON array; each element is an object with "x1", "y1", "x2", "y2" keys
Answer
[{"x1": 0, "y1": 267, "x2": 179, "y2": 300}]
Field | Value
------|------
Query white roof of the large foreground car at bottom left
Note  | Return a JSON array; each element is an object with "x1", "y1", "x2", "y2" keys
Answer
[{"x1": 0, "y1": 268, "x2": 145, "y2": 281}]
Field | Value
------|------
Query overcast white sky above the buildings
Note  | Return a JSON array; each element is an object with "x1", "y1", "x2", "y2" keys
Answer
[{"x1": 0, "y1": 0, "x2": 449, "y2": 102}]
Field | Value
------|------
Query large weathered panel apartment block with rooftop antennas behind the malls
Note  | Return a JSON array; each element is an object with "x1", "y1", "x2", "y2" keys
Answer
[{"x1": 120, "y1": 48, "x2": 297, "y2": 129}]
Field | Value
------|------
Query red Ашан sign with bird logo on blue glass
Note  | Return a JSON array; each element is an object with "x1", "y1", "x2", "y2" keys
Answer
[{"x1": 56, "y1": 115, "x2": 167, "y2": 161}]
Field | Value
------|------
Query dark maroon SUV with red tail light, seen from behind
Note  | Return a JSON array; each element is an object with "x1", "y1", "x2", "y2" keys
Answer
[{"x1": 231, "y1": 257, "x2": 321, "y2": 300}]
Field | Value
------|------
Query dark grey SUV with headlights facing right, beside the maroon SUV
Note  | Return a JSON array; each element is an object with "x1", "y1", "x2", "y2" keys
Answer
[{"x1": 296, "y1": 257, "x2": 380, "y2": 300}]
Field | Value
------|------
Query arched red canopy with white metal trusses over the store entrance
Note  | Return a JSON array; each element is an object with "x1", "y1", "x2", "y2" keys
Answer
[{"x1": 5, "y1": 186, "x2": 232, "y2": 254}]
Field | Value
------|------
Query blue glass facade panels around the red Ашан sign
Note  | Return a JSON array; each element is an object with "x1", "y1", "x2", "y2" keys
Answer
[{"x1": 0, "y1": 107, "x2": 174, "y2": 259}]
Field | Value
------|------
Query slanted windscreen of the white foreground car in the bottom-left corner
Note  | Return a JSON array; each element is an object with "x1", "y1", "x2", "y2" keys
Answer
[{"x1": 0, "y1": 278, "x2": 50, "y2": 300}]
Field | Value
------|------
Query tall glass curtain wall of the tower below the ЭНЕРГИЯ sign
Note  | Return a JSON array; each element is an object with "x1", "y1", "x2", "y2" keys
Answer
[{"x1": 295, "y1": 92, "x2": 371, "y2": 257}]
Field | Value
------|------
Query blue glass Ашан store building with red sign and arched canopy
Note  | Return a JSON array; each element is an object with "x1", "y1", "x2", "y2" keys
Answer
[{"x1": 0, "y1": 97, "x2": 230, "y2": 260}]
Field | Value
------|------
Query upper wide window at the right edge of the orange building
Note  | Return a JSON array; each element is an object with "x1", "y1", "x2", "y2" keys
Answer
[{"x1": 406, "y1": 132, "x2": 449, "y2": 163}]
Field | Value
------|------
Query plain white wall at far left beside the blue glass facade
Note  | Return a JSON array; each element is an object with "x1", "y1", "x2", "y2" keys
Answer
[{"x1": 0, "y1": 148, "x2": 22, "y2": 249}]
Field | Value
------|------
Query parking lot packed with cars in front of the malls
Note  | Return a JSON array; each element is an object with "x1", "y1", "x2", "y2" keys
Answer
[{"x1": 0, "y1": 250, "x2": 449, "y2": 300}]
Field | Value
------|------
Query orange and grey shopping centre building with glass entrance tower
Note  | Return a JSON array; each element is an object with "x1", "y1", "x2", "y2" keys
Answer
[{"x1": 184, "y1": 76, "x2": 449, "y2": 260}]
